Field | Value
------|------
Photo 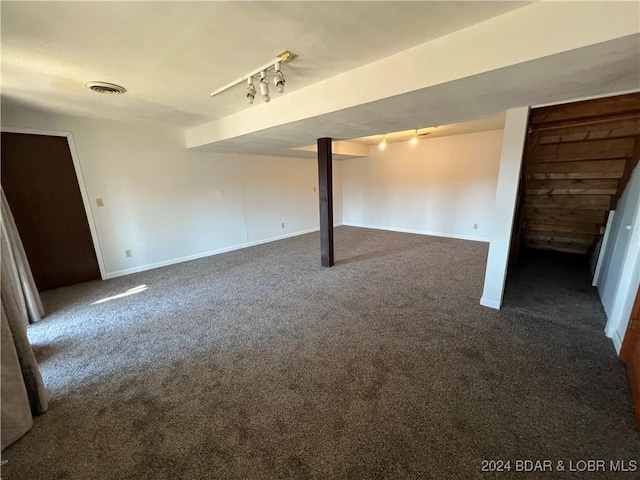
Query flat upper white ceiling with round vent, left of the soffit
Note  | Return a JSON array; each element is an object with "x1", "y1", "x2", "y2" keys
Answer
[{"x1": 1, "y1": 1, "x2": 530, "y2": 129}]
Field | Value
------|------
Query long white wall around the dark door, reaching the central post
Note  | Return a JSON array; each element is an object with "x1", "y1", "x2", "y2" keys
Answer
[{"x1": 2, "y1": 108, "x2": 342, "y2": 278}]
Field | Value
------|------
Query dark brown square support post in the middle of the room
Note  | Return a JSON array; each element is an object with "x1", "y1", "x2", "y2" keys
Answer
[{"x1": 318, "y1": 138, "x2": 333, "y2": 267}]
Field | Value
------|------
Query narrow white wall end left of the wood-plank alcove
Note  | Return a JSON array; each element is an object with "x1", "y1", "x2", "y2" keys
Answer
[{"x1": 480, "y1": 107, "x2": 529, "y2": 308}]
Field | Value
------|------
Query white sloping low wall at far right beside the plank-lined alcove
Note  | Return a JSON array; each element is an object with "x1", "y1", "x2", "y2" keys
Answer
[{"x1": 597, "y1": 166, "x2": 640, "y2": 352}]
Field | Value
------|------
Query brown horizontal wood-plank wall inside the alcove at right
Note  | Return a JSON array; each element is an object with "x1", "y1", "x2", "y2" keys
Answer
[{"x1": 517, "y1": 93, "x2": 640, "y2": 253}]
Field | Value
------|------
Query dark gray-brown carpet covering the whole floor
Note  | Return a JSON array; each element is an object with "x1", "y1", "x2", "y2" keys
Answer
[{"x1": 2, "y1": 227, "x2": 640, "y2": 480}]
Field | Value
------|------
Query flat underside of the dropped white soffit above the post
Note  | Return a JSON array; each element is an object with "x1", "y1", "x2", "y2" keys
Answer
[{"x1": 189, "y1": 31, "x2": 640, "y2": 158}]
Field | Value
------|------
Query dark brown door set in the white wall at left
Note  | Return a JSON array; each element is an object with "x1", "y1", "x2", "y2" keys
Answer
[{"x1": 1, "y1": 132, "x2": 100, "y2": 291}]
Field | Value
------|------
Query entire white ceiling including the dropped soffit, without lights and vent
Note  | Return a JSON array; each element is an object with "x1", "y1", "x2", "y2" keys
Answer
[{"x1": 0, "y1": 1, "x2": 640, "y2": 156}]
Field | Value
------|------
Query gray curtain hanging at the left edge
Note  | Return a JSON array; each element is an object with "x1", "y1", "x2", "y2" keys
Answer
[{"x1": 0, "y1": 187, "x2": 48, "y2": 450}]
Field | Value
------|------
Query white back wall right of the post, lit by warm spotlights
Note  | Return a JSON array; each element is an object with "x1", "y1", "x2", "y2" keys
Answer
[{"x1": 342, "y1": 130, "x2": 502, "y2": 241}]
